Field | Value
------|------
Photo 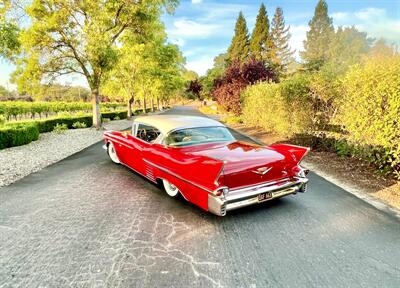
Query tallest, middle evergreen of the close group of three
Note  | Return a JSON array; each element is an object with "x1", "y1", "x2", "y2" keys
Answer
[{"x1": 250, "y1": 3, "x2": 270, "y2": 60}]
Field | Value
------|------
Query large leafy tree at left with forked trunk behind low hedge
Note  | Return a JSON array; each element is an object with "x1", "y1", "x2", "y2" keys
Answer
[{"x1": 14, "y1": 0, "x2": 176, "y2": 127}]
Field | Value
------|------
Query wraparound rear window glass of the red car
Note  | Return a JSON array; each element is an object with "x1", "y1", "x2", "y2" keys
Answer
[{"x1": 165, "y1": 127, "x2": 234, "y2": 146}]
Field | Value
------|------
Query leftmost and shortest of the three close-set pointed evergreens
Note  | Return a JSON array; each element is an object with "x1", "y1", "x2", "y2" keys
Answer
[{"x1": 228, "y1": 12, "x2": 249, "y2": 62}]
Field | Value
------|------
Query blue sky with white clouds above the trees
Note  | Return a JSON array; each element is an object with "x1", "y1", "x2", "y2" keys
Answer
[{"x1": 0, "y1": 0, "x2": 400, "y2": 87}]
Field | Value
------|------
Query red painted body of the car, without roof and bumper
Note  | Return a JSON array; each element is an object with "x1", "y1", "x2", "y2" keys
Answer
[{"x1": 104, "y1": 132, "x2": 309, "y2": 210}]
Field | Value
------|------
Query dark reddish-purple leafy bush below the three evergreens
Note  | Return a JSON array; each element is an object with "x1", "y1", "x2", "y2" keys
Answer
[{"x1": 212, "y1": 59, "x2": 276, "y2": 115}]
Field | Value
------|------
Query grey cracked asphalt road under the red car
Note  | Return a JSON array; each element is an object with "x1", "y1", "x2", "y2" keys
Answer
[{"x1": 0, "y1": 108, "x2": 400, "y2": 287}]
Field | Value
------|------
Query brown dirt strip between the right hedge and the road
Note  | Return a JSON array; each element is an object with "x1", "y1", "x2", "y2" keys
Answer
[{"x1": 229, "y1": 124, "x2": 400, "y2": 209}]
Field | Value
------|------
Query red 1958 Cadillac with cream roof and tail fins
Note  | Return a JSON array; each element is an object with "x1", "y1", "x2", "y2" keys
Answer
[{"x1": 103, "y1": 115, "x2": 309, "y2": 216}]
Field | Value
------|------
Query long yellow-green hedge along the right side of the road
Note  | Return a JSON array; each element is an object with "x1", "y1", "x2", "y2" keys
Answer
[{"x1": 241, "y1": 55, "x2": 400, "y2": 179}]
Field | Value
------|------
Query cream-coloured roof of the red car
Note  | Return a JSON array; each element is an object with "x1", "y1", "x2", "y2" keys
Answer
[{"x1": 134, "y1": 115, "x2": 225, "y2": 135}]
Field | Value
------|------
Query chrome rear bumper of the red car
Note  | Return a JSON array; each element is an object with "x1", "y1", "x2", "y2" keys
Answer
[{"x1": 208, "y1": 177, "x2": 308, "y2": 216}]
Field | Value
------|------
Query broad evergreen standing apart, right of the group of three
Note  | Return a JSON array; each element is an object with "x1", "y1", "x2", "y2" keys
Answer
[{"x1": 300, "y1": 0, "x2": 335, "y2": 69}]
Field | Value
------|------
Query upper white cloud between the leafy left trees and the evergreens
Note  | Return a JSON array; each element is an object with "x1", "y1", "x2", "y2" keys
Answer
[{"x1": 168, "y1": 19, "x2": 220, "y2": 38}]
